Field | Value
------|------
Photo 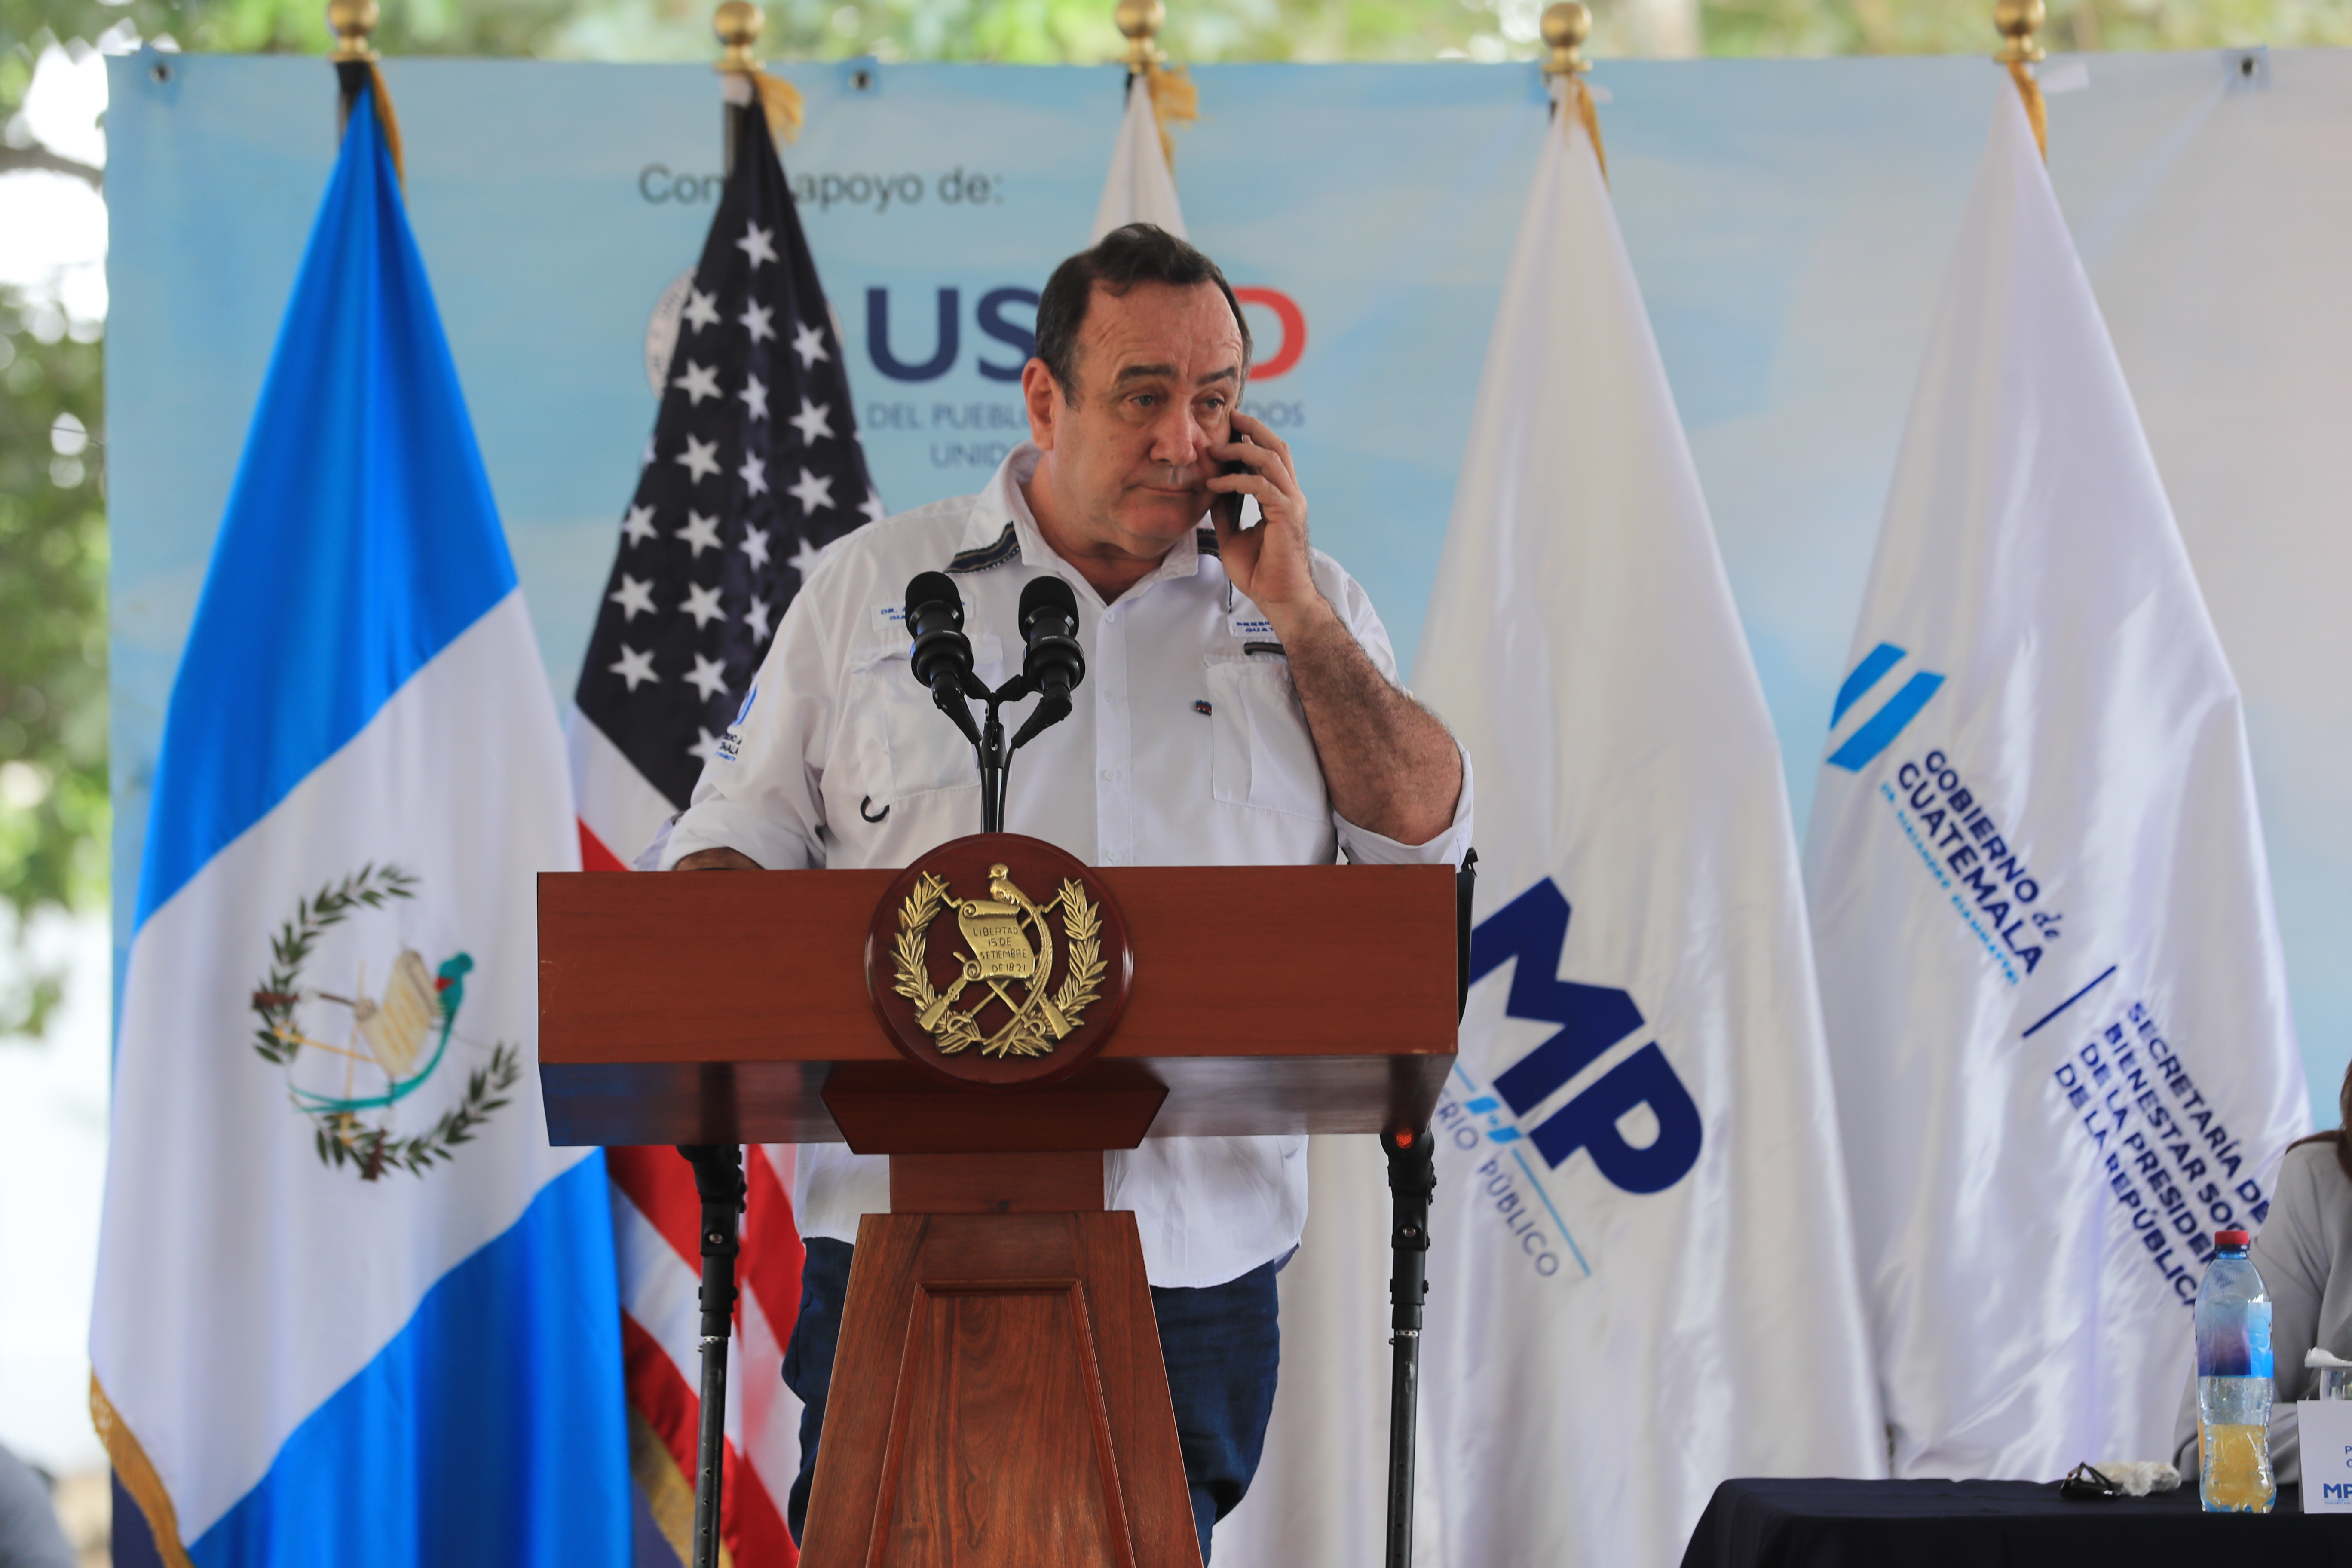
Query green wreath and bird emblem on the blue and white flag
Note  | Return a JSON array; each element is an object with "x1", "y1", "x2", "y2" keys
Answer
[{"x1": 254, "y1": 863, "x2": 522, "y2": 1182}]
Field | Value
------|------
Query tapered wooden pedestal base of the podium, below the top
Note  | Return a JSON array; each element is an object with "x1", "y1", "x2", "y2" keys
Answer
[{"x1": 802, "y1": 1194, "x2": 1200, "y2": 1568}]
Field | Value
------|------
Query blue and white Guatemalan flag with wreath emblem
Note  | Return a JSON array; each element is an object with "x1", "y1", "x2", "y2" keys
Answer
[{"x1": 92, "y1": 82, "x2": 630, "y2": 1568}]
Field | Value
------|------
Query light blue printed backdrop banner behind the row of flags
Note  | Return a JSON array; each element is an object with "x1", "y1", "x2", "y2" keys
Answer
[{"x1": 106, "y1": 49, "x2": 2352, "y2": 1563}]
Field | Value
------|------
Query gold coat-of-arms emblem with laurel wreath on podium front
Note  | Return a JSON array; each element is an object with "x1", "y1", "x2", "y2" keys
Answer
[{"x1": 891, "y1": 867, "x2": 1108, "y2": 1056}]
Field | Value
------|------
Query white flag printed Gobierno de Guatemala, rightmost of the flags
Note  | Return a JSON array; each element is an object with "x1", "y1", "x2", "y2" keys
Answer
[{"x1": 1806, "y1": 85, "x2": 2307, "y2": 1481}]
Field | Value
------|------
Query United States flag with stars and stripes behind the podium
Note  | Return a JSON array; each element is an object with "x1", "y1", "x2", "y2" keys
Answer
[{"x1": 569, "y1": 106, "x2": 882, "y2": 1568}]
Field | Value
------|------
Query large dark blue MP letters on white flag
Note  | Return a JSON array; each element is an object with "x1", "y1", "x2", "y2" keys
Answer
[{"x1": 1465, "y1": 877, "x2": 1700, "y2": 1192}]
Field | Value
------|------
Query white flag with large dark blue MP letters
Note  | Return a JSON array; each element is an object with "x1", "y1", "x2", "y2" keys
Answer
[{"x1": 1416, "y1": 85, "x2": 1884, "y2": 1568}]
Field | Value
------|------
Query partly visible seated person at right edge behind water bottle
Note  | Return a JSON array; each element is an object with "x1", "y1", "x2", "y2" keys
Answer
[{"x1": 2173, "y1": 1067, "x2": 2352, "y2": 1486}]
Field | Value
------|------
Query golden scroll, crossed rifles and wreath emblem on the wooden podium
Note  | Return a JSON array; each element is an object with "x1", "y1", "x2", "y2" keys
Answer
[{"x1": 894, "y1": 861, "x2": 1103, "y2": 1056}]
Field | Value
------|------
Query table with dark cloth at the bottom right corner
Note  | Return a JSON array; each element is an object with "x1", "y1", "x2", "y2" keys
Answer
[{"x1": 1681, "y1": 1481, "x2": 2352, "y2": 1568}]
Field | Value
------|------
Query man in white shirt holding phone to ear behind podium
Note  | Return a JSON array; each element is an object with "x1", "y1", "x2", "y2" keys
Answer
[{"x1": 661, "y1": 224, "x2": 1470, "y2": 1559}]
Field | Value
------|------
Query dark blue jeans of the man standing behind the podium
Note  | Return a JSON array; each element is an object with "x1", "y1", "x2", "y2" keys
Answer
[{"x1": 783, "y1": 1237, "x2": 1289, "y2": 1566}]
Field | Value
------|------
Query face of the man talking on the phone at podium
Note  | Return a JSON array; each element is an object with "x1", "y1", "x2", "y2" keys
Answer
[{"x1": 1023, "y1": 282, "x2": 1244, "y2": 560}]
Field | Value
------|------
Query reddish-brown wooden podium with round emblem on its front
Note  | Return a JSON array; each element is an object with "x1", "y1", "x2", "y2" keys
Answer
[{"x1": 539, "y1": 837, "x2": 1458, "y2": 1568}]
